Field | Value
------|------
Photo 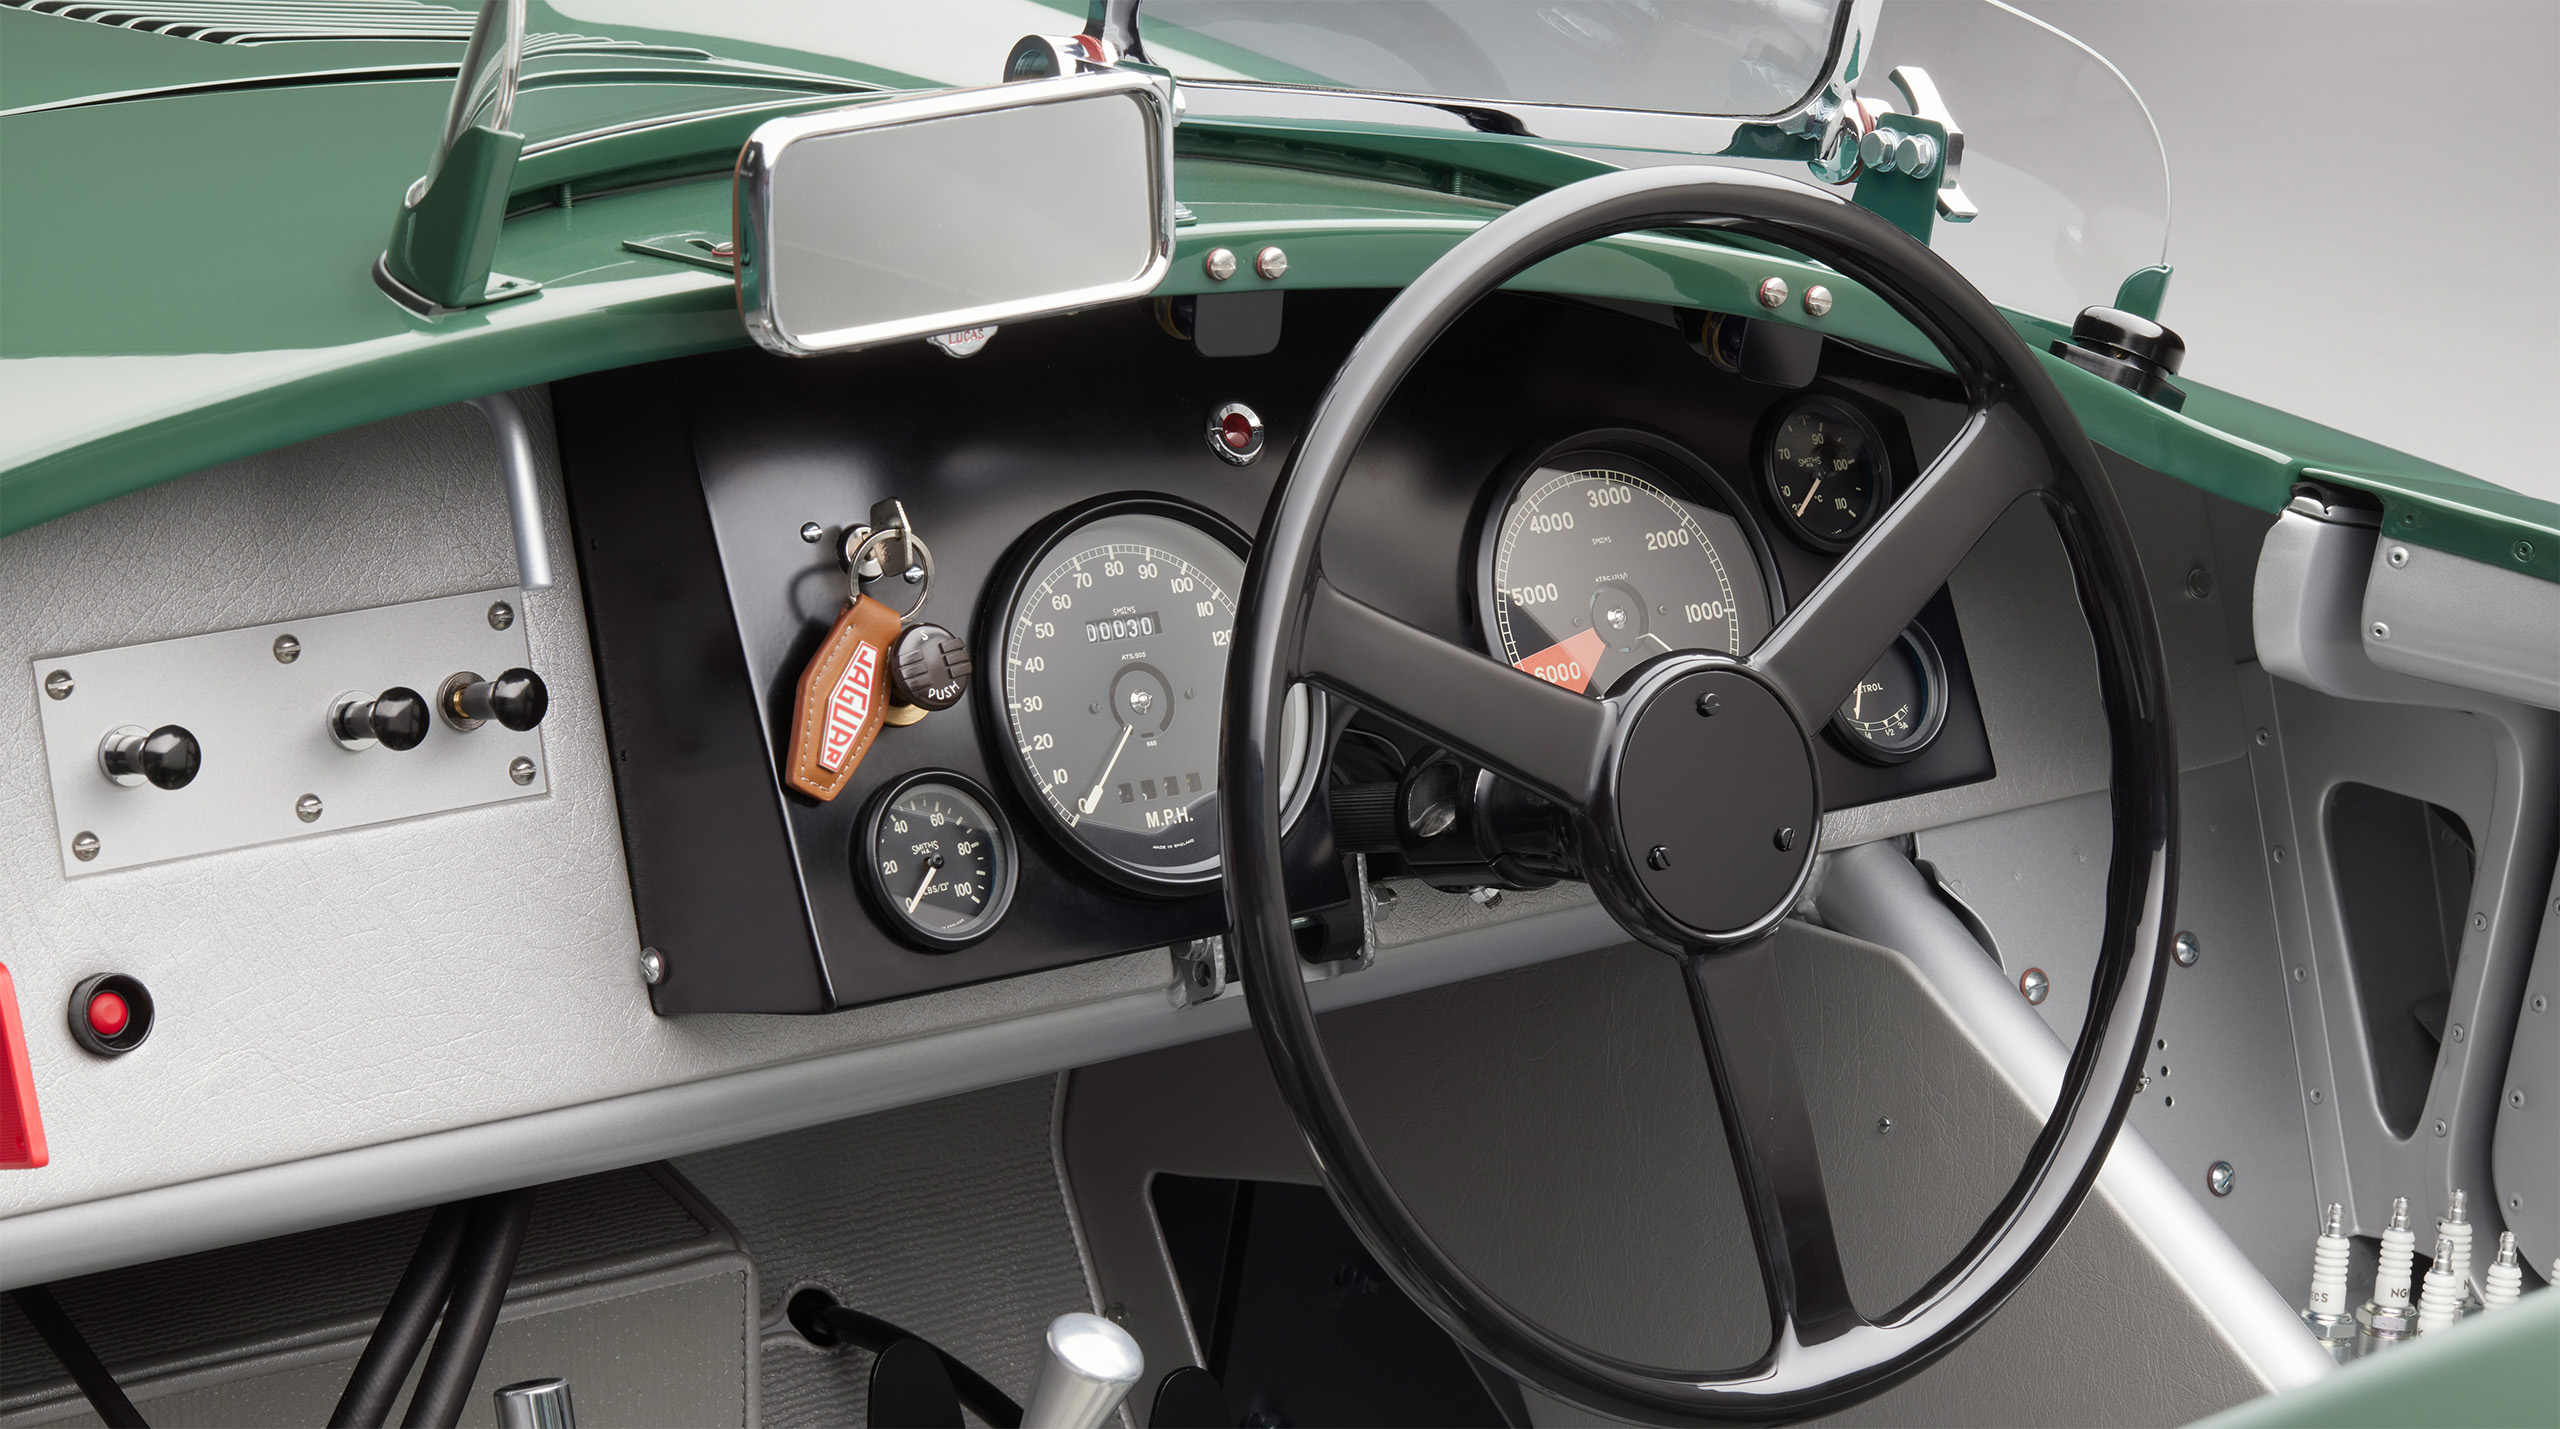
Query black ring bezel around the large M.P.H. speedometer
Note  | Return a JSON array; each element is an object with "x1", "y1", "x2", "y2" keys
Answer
[{"x1": 970, "y1": 492, "x2": 1326, "y2": 896}]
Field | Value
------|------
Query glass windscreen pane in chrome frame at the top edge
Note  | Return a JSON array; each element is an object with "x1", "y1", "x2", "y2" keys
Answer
[{"x1": 1137, "y1": 0, "x2": 1843, "y2": 115}]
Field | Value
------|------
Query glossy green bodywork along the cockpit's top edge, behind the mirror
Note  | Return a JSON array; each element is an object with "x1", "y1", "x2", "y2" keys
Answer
[{"x1": 0, "y1": 5, "x2": 2560, "y2": 581}]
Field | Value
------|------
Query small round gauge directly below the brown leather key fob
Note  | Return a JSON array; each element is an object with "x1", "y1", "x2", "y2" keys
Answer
[{"x1": 855, "y1": 771, "x2": 1014, "y2": 953}]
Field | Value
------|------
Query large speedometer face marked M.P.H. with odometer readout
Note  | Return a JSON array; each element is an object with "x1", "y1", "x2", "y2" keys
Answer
[{"x1": 988, "y1": 497, "x2": 1308, "y2": 886}]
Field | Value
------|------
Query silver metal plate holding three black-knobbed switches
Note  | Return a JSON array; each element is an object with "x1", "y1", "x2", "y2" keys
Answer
[{"x1": 28, "y1": 589, "x2": 550, "y2": 878}]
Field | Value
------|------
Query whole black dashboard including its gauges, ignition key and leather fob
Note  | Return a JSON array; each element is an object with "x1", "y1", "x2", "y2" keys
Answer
[{"x1": 553, "y1": 292, "x2": 1994, "y2": 1014}]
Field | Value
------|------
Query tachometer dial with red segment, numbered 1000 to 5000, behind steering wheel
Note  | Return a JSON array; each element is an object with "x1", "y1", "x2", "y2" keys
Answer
[{"x1": 1480, "y1": 448, "x2": 1769, "y2": 694}]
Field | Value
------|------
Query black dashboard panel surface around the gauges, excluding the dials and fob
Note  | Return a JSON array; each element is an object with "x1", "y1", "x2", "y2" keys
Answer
[{"x1": 553, "y1": 292, "x2": 1992, "y2": 1014}]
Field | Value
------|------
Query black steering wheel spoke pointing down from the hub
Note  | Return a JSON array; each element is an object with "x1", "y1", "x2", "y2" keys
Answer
[{"x1": 1679, "y1": 937, "x2": 1866, "y2": 1352}]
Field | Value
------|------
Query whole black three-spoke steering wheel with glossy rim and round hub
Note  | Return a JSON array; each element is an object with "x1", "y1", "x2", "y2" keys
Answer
[{"x1": 1224, "y1": 166, "x2": 2179, "y2": 1424}]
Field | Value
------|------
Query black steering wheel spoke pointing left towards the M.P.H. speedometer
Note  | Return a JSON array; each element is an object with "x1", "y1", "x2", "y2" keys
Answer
[{"x1": 1298, "y1": 576, "x2": 1618, "y2": 809}]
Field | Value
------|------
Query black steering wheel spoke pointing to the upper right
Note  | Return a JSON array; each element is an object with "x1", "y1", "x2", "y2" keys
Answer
[{"x1": 1751, "y1": 402, "x2": 2053, "y2": 720}]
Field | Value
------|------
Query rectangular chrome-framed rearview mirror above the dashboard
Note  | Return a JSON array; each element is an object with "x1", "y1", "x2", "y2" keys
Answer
[{"x1": 737, "y1": 72, "x2": 1172, "y2": 356}]
